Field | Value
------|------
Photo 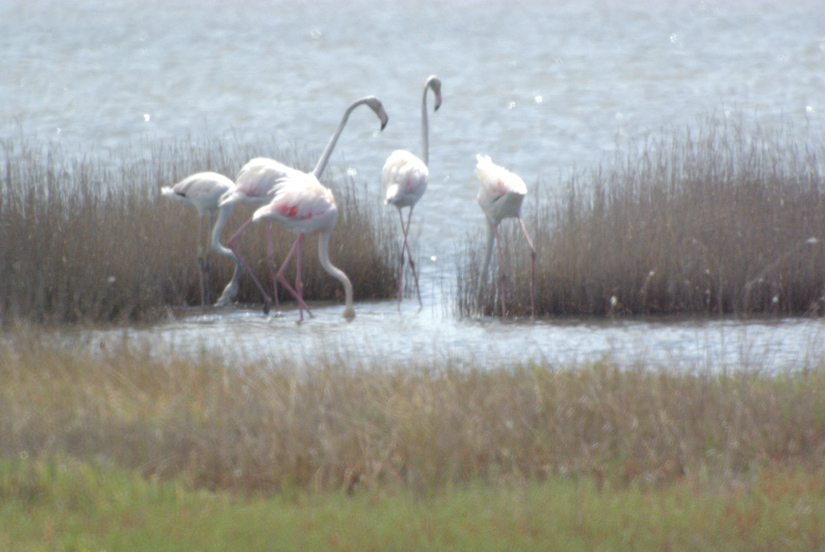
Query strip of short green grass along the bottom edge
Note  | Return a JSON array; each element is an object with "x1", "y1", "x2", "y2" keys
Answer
[{"x1": 0, "y1": 457, "x2": 825, "y2": 552}]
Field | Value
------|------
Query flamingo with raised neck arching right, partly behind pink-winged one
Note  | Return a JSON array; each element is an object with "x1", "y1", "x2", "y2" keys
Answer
[{"x1": 220, "y1": 96, "x2": 388, "y2": 314}]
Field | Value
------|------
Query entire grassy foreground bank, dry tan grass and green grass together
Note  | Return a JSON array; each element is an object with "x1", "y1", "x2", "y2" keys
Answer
[{"x1": 0, "y1": 330, "x2": 825, "y2": 551}]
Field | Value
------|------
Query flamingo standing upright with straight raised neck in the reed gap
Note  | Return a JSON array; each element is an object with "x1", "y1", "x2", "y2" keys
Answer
[{"x1": 381, "y1": 75, "x2": 441, "y2": 310}]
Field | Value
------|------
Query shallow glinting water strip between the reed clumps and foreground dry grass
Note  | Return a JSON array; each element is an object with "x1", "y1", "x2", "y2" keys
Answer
[{"x1": 79, "y1": 302, "x2": 825, "y2": 373}]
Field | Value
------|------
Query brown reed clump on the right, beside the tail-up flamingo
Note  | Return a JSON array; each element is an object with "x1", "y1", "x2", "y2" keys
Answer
[{"x1": 456, "y1": 118, "x2": 825, "y2": 315}]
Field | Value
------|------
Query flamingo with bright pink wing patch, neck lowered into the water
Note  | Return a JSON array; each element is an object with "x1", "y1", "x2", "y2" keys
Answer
[{"x1": 252, "y1": 171, "x2": 355, "y2": 321}]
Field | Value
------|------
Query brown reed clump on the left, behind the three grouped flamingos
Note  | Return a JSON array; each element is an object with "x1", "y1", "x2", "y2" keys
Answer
[{"x1": 0, "y1": 138, "x2": 398, "y2": 323}]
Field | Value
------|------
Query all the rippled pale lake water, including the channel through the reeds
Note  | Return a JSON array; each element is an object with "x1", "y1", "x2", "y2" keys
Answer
[{"x1": 0, "y1": 0, "x2": 825, "y2": 368}]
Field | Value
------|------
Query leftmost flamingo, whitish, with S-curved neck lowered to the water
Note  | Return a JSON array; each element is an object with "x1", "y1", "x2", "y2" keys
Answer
[{"x1": 160, "y1": 172, "x2": 242, "y2": 307}]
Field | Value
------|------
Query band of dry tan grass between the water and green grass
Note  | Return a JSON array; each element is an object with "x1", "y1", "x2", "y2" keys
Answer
[{"x1": 0, "y1": 330, "x2": 825, "y2": 494}]
